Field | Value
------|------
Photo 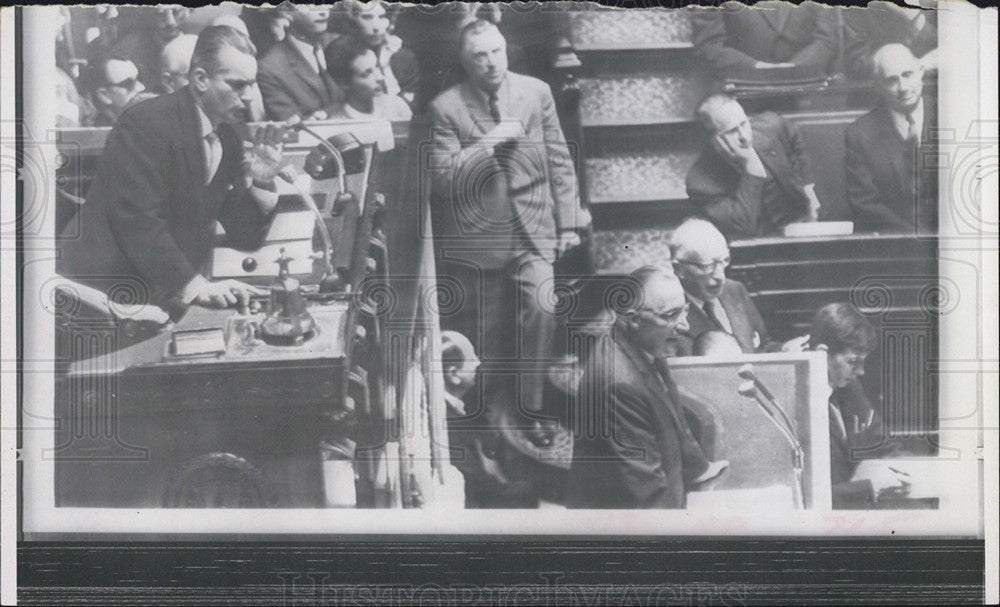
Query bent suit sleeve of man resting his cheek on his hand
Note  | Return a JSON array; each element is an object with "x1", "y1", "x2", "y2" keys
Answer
[{"x1": 687, "y1": 164, "x2": 765, "y2": 238}]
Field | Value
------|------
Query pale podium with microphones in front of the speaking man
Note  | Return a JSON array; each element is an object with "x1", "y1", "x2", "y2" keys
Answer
[{"x1": 670, "y1": 352, "x2": 830, "y2": 509}]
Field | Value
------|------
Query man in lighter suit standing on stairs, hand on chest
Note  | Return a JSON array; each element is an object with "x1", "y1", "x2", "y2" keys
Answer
[{"x1": 423, "y1": 21, "x2": 590, "y2": 418}]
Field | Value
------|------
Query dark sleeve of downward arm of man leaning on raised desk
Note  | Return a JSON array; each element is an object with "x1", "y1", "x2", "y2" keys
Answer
[{"x1": 99, "y1": 114, "x2": 197, "y2": 297}]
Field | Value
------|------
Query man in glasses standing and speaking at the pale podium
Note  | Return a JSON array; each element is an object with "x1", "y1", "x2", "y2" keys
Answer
[{"x1": 566, "y1": 267, "x2": 728, "y2": 508}]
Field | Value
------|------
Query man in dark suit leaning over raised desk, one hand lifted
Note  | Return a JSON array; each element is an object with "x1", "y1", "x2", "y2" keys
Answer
[{"x1": 66, "y1": 26, "x2": 281, "y2": 307}]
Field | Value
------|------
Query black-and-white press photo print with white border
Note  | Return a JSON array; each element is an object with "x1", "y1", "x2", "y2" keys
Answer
[{"x1": 0, "y1": 0, "x2": 1000, "y2": 604}]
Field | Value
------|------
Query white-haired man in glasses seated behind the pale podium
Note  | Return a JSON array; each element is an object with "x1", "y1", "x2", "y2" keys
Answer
[{"x1": 670, "y1": 218, "x2": 806, "y2": 356}]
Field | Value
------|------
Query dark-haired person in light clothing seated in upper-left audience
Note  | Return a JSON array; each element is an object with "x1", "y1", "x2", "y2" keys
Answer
[{"x1": 326, "y1": 36, "x2": 413, "y2": 121}]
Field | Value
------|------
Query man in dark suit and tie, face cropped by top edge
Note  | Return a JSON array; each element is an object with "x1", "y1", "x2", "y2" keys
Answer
[{"x1": 257, "y1": 2, "x2": 344, "y2": 120}]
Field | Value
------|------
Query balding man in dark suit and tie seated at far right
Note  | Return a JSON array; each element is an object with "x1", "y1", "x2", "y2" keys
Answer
[{"x1": 844, "y1": 44, "x2": 938, "y2": 233}]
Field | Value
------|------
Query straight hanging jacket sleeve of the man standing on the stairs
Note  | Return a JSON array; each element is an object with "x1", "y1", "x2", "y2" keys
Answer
[{"x1": 541, "y1": 85, "x2": 590, "y2": 230}]
